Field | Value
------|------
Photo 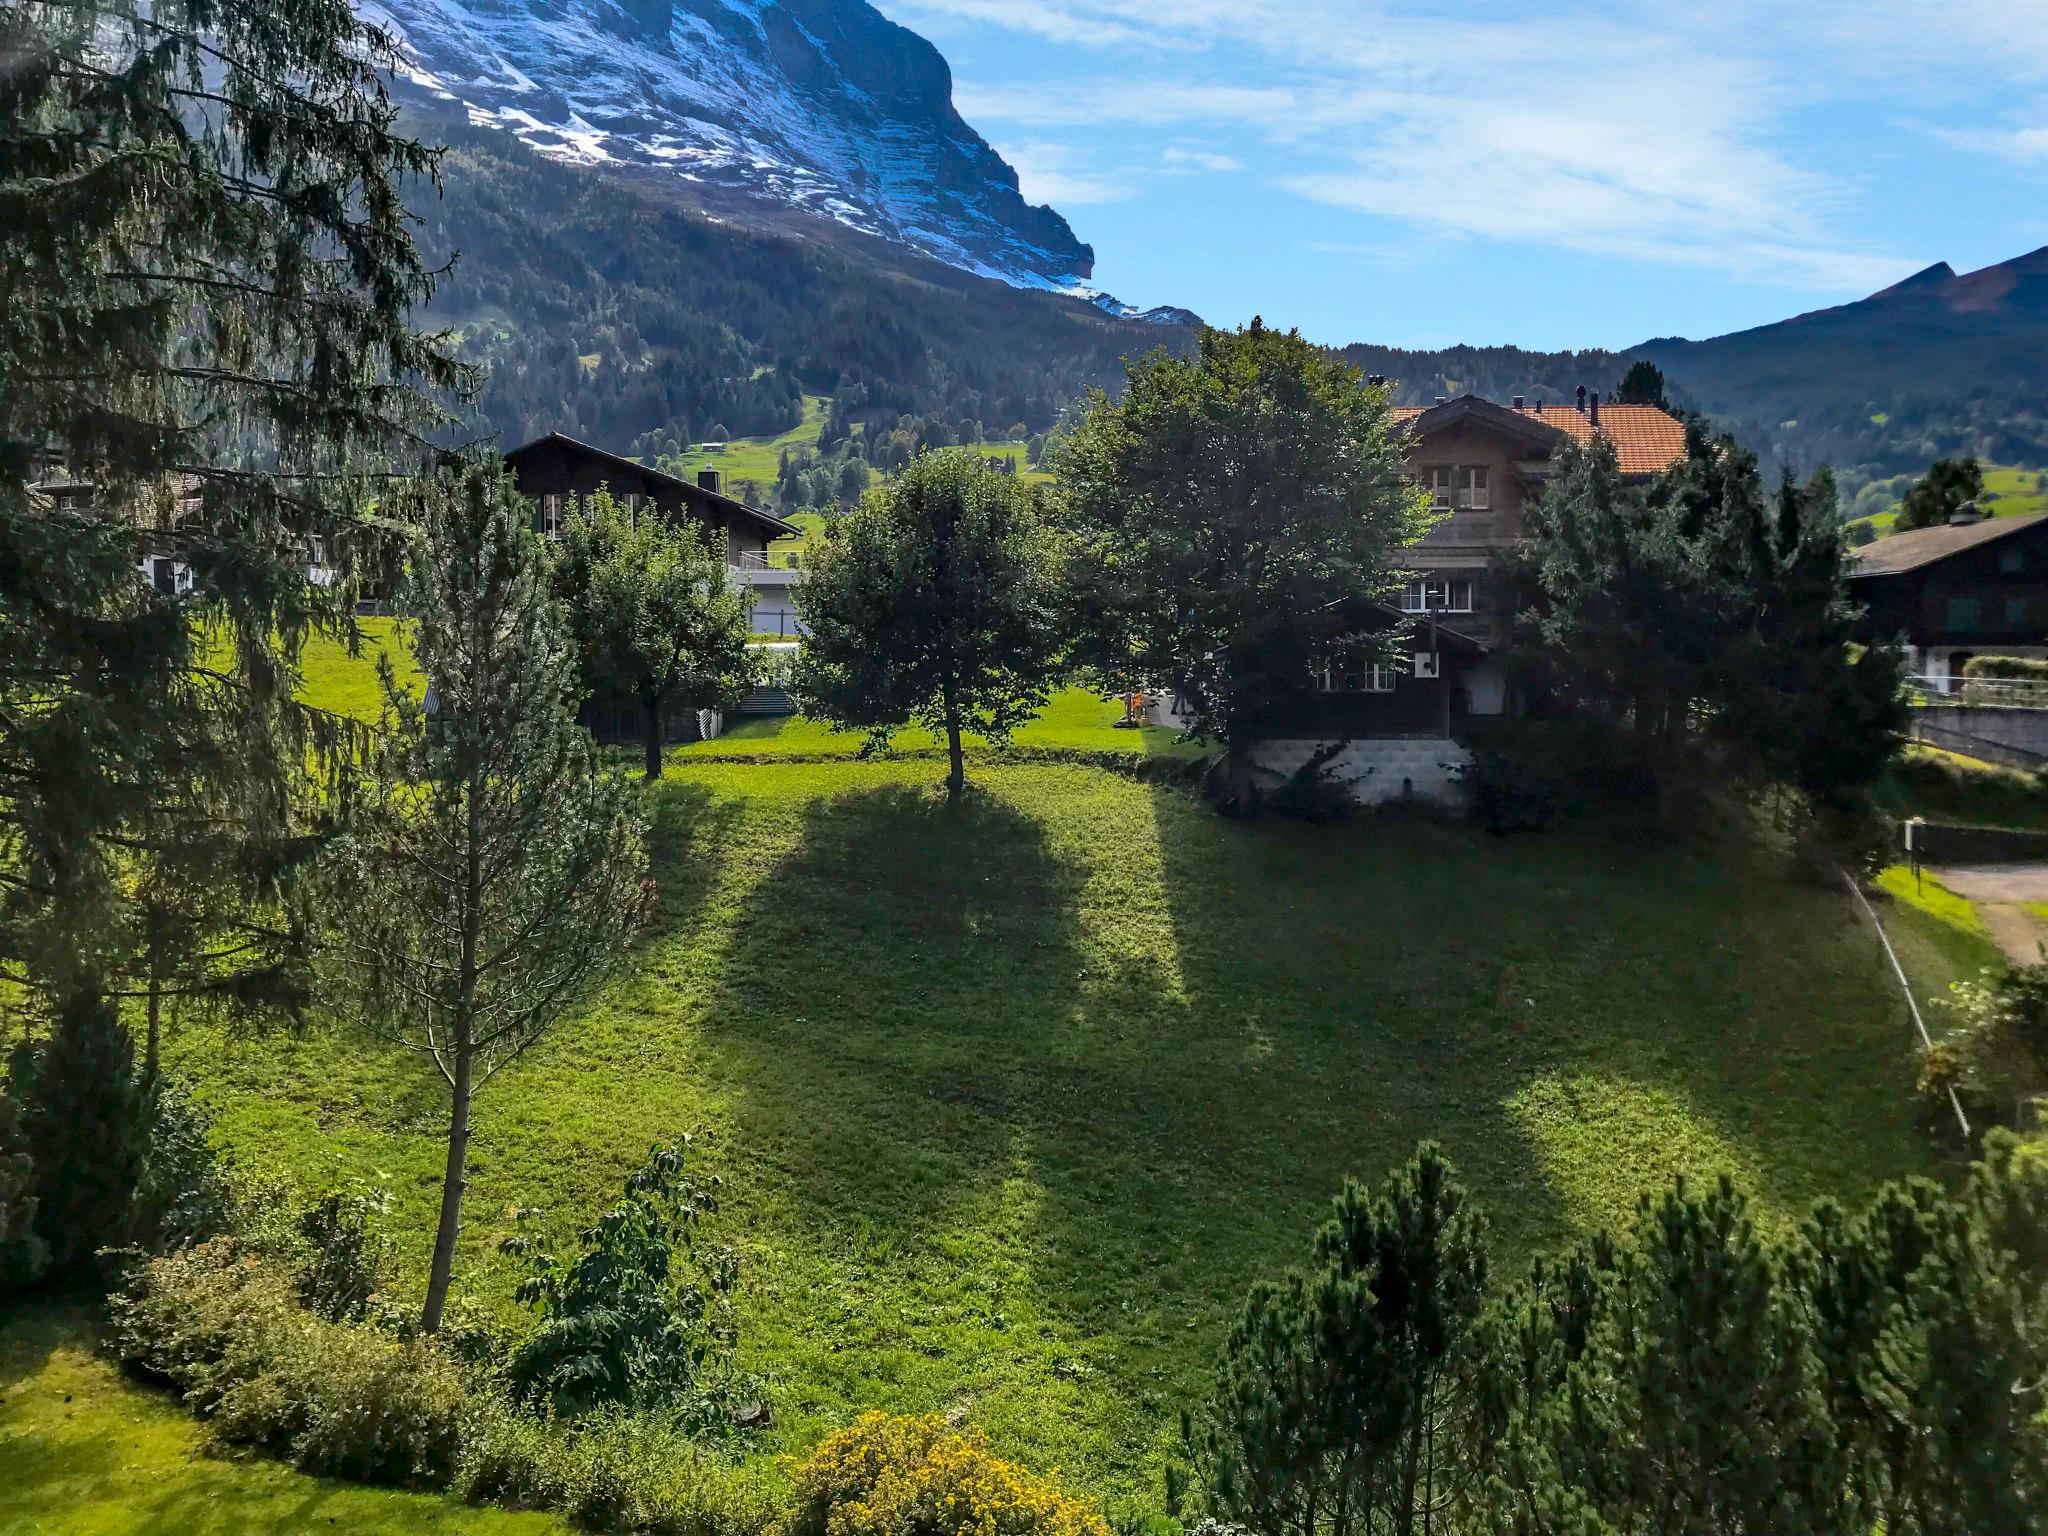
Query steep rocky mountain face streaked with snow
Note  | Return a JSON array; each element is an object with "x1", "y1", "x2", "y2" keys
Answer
[{"x1": 368, "y1": 0, "x2": 1098, "y2": 288}]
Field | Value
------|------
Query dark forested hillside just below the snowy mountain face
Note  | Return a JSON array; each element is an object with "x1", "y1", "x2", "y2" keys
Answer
[{"x1": 416, "y1": 119, "x2": 1186, "y2": 453}]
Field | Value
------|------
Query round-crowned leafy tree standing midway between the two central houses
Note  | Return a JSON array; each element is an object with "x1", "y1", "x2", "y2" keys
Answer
[{"x1": 791, "y1": 449, "x2": 1061, "y2": 805}]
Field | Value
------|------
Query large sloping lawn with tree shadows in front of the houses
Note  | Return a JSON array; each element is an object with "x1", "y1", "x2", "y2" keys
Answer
[{"x1": 155, "y1": 758, "x2": 1927, "y2": 1505}]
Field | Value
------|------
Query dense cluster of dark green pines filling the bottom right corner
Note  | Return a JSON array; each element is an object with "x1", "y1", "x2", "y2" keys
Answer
[{"x1": 1186, "y1": 1130, "x2": 2048, "y2": 1536}]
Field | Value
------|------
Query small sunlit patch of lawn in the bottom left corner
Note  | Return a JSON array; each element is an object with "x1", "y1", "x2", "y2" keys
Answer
[{"x1": 0, "y1": 1311, "x2": 567, "y2": 1536}]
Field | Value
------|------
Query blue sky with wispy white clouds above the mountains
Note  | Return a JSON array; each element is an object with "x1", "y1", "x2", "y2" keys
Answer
[{"x1": 877, "y1": 0, "x2": 2048, "y2": 348}]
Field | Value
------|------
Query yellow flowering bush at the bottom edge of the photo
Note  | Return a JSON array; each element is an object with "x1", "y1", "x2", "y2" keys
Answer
[{"x1": 791, "y1": 1413, "x2": 1110, "y2": 1536}]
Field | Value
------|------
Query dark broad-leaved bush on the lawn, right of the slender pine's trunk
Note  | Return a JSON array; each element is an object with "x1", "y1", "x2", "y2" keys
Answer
[{"x1": 506, "y1": 1139, "x2": 739, "y2": 1427}]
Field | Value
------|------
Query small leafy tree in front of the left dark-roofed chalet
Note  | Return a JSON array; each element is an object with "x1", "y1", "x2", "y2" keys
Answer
[{"x1": 555, "y1": 489, "x2": 754, "y2": 778}]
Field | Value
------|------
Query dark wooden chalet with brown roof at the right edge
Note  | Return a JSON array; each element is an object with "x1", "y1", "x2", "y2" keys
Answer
[{"x1": 1849, "y1": 516, "x2": 2048, "y2": 678}]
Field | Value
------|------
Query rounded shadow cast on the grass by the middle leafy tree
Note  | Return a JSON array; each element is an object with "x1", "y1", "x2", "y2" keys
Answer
[{"x1": 702, "y1": 786, "x2": 1077, "y2": 1245}]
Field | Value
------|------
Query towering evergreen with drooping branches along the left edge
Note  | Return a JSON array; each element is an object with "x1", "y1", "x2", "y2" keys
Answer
[{"x1": 0, "y1": 0, "x2": 467, "y2": 1251}]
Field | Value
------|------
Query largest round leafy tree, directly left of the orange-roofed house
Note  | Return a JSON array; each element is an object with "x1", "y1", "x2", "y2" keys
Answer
[{"x1": 1057, "y1": 322, "x2": 1430, "y2": 809}]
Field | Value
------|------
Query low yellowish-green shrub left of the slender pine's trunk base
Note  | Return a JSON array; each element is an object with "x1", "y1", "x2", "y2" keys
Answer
[{"x1": 111, "y1": 1237, "x2": 471, "y2": 1489}]
